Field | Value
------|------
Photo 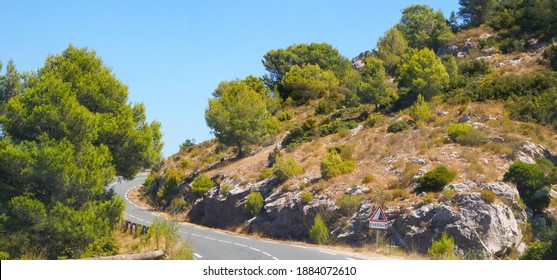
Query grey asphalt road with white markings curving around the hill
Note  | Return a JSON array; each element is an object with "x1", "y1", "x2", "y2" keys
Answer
[{"x1": 110, "y1": 176, "x2": 355, "y2": 260}]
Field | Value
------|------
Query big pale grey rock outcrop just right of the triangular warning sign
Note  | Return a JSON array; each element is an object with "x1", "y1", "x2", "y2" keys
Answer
[{"x1": 389, "y1": 193, "x2": 522, "y2": 257}]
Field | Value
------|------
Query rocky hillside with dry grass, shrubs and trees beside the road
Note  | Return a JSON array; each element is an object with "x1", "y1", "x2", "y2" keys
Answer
[{"x1": 142, "y1": 2, "x2": 557, "y2": 259}]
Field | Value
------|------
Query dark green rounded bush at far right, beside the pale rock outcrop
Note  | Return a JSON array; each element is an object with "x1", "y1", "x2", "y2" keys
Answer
[{"x1": 503, "y1": 161, "x2": 550, "y2": 210}]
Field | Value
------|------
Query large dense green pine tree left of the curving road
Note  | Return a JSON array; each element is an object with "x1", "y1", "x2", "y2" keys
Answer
[{"x1": 0, "y1": 46, "x2": 162, "y2": 259}]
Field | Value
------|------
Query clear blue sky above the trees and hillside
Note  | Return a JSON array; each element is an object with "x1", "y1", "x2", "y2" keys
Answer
[{"x1": 0, "y1": 0, "x2": 458, "y2": 156}]
